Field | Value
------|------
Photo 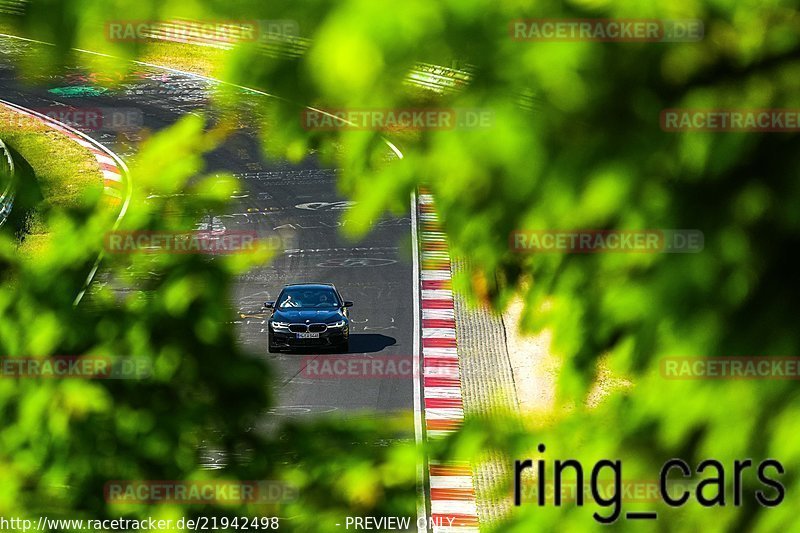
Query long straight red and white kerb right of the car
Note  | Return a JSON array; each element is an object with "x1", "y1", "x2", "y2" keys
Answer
[{"x1": 418, "y1": 191, "x2": 478, "y2": 533}]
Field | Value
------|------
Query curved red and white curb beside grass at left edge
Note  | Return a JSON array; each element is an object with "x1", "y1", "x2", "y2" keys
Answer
[{"x1": 0, "y1": 100, "x2": 125, "y2": 206}]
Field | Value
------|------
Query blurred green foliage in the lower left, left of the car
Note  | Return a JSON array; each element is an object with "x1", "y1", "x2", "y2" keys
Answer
[{"x1": 0, "y1": 111, "x2": 418, "y2": 531}]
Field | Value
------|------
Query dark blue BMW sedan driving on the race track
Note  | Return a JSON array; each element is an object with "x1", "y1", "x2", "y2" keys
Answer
[{"x1": 264, "y1": 283, "x2": 353, "y2": 353}]
